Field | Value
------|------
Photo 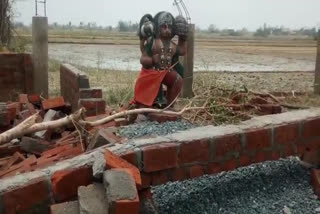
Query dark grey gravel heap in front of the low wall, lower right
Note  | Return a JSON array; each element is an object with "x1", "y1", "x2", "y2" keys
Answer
[{"x1": 152, "y1": 158, "x2": 320, "y2": 214}]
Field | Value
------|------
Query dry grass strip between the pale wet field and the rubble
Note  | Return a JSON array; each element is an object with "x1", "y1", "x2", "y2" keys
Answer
[{"x1": 49, "y1": 58, "x2": 320, "y2": 125}]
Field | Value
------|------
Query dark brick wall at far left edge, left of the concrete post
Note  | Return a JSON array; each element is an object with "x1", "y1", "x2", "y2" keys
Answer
[{"x1": 0, "y1": 53, "x2": 33, "y2": 102}]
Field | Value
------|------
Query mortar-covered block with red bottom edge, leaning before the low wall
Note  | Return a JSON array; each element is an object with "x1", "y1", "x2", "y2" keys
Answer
[{"x1": 103, "y1": 169, "x2": 139, "y2": 213}]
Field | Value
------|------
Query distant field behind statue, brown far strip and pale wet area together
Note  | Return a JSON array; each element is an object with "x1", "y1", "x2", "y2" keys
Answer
[{"x1": 40, "y1": 32, "x2": 316, "y2": 72}]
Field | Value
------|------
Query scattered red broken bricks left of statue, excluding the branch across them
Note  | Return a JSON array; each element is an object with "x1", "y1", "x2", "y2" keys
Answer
[{"x1": 0, "y1": 94, "x2": 126, "y2": 178}]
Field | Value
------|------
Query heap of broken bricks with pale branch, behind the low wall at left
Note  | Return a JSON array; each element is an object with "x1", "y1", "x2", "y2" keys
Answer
[{"x1": 0, "y1": 94, "x2": 185, "y2": 178}]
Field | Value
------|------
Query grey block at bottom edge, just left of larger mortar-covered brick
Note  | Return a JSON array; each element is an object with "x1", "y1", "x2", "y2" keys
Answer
[{"x1": 78, "y1": 183, "x2": 108, "y2": 214}]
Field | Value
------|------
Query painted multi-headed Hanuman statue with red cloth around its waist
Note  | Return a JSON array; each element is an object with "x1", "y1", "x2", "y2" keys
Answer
[{"x1": 131, "y1": 11, "x2": 188, "y2": 108}]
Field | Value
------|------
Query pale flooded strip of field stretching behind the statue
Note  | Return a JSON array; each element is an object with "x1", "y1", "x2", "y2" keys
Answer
[{"x1": 49, "y1": 42, "x2": 316, "y2": 72}]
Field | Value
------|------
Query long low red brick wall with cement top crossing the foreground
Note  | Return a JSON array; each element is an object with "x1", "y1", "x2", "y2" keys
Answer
[{"x1": 0, "y1": 109, "x2": 320, "y2": 213}]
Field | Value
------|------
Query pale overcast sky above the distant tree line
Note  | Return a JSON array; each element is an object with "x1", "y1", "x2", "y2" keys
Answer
[{"x1": 14, "y1": 0, "x2": 320, "y2": 30}]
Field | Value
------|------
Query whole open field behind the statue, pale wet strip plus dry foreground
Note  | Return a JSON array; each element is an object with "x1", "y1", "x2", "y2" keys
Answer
[{"x1": 45, "y1": 35, "x2": 320, "y2": 121}]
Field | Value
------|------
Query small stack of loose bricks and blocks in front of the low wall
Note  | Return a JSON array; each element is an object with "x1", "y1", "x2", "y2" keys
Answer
[{"x1": 50, "y1": 150, "x2": 156, "y2": 214}]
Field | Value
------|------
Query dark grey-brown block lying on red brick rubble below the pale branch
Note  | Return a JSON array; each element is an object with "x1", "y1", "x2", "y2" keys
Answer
[{"x1": 20, "y1": 137, "x2": 52, "y2": 155}]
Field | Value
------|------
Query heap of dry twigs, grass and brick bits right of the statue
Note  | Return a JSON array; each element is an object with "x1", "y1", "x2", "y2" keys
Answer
[{"x1": 178, "y1": 83, "x2": 307, "y2": 125}]
